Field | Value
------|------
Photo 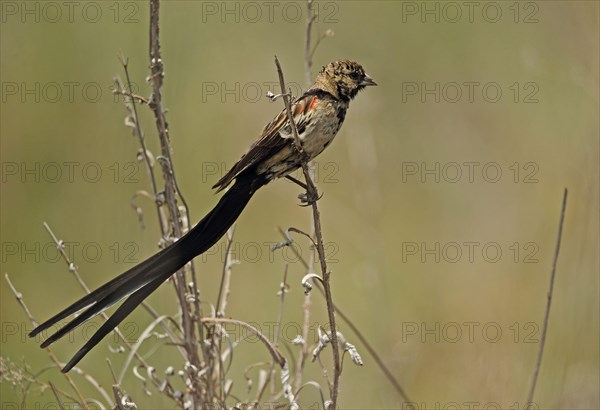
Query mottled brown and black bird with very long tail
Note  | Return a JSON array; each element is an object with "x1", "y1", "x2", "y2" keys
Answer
[{"x1": 29, "y1": 60, "x2": 377, "y2": 373}]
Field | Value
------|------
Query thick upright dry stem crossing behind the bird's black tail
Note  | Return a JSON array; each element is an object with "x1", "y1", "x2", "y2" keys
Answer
[{"x1": 149, "y1": 0, "x2": 208, "y2": 407}]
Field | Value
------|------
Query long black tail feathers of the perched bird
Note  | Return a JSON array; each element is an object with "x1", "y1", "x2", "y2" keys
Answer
[{"x1": 29, "y1": 172, "x2": 268, "y2": 372}]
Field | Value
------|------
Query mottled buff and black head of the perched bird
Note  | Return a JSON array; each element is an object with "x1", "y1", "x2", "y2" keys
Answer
[{"x1": 313, "y1": 60, "x2": 377, "y2": 100}]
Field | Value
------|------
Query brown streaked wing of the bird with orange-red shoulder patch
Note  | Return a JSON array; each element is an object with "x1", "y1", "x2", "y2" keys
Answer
[{"x1": 213, "y1": 93, "x2": 318, "y2": 192}]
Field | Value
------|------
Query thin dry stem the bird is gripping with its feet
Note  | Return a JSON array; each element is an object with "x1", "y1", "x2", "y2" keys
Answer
[{"x1": 275, "y1": 53, "x2": 341, "y2": 409}]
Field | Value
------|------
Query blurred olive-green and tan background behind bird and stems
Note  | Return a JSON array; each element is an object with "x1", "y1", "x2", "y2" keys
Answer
[{"x1": 0, "y1": 1, "x2": 600, "y2": 409}]
